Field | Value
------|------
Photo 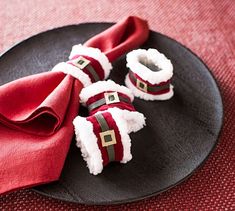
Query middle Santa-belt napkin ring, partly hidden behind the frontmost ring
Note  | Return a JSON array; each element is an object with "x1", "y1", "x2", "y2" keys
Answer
[{"x1": 80, "y1": 80, "x2": 135, "y2": 115}]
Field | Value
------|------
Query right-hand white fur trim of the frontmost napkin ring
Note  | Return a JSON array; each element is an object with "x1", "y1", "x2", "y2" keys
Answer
[{"x1": 98, "y1": 108, "x2": 145, "y2": 163}]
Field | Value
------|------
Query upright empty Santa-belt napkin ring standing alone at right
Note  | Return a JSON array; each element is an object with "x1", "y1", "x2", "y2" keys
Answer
[{"x1": 125, "y1": 48, "x2": 174, "y2": 100}]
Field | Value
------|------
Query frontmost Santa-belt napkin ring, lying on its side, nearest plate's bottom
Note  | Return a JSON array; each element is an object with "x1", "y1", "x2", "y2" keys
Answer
[{"x1": 73, "y1": 108, "x2": 145, "y2": 175}]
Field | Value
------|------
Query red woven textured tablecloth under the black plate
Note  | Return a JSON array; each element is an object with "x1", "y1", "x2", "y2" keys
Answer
[{"x1": 0, "y1": 0, "x2": 235, "y2": 210}]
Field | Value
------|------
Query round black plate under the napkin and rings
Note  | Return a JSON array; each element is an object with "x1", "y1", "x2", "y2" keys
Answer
[{"x1": 0, "y1": 23, "x2": 223, "y2": 204}]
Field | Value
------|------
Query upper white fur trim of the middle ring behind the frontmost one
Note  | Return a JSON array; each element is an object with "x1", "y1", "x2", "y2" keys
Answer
[{"x1": 80, "y1": 80, "x2": 134, "y2": 104}]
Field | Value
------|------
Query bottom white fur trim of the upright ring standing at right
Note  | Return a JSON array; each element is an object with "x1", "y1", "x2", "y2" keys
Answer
[{"x1": 125, "y1": 74, "x2": 174, "y2": 101}]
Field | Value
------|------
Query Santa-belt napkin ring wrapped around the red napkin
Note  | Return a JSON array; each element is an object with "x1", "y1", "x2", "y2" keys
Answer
[{"x1": 52, "y1": 44, "x2": 112, "y2": 87}]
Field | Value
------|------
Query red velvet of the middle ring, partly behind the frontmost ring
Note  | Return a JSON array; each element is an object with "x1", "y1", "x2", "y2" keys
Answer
[{"x1": 86, "y1": 91, "x2": 135, "y2": 115}]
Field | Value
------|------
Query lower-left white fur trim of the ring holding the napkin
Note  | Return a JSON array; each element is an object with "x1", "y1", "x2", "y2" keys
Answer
[{"x1": 51, "y1": 62, "x2": 92, "y2": 87}]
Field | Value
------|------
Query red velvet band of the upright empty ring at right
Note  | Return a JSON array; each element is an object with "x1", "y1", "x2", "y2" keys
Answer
[{"x1": 128, "y1": 70, "x2": 170, "y2": 95}]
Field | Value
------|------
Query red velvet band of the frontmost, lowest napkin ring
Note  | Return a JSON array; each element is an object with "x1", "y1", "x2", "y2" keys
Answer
[{"x1": 87, "y1": 112, "x2": 123, "y2": 166}]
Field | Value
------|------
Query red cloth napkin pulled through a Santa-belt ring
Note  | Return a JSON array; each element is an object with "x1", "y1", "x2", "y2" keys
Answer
[{"x1": 0, "y1": 17, "x2": 149, "y2": 193}]
